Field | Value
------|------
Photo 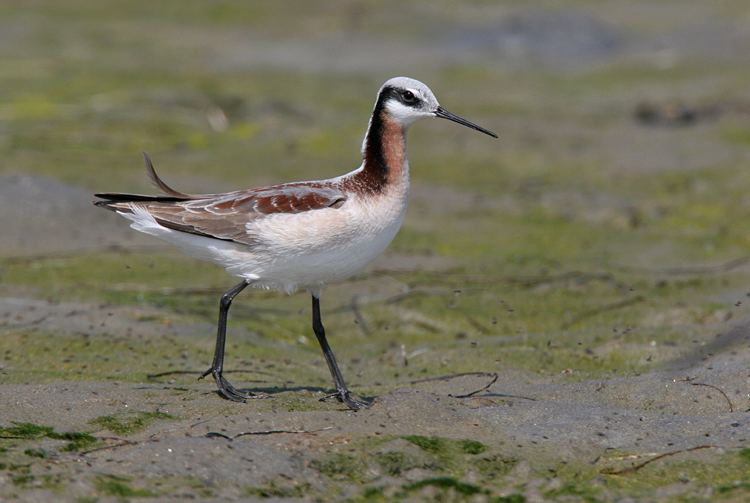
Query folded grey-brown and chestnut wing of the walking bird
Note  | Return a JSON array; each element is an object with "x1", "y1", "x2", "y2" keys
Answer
[{"x1": 136, "y1": 183, "x2": 346, "y2": 244}]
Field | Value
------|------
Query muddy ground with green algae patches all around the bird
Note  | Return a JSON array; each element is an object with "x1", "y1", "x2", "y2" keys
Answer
[{"x1": 0, "y1": 1, "x2": 750, "y2": 502}]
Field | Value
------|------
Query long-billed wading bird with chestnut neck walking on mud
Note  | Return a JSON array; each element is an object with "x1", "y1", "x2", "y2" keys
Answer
[{"x1": 94, "y1": 77, "x2": 498, "y2": 411}]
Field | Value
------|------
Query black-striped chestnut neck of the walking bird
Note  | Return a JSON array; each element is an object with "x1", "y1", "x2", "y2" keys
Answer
[{"x1": 360, "y1": 106, "x2": 409, "y2": 193}]
